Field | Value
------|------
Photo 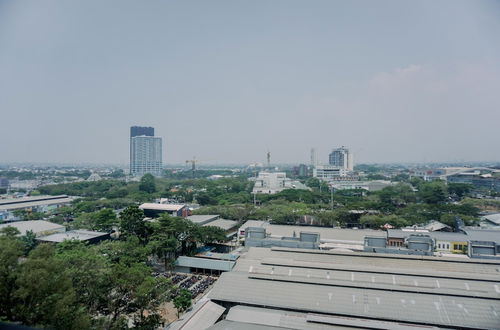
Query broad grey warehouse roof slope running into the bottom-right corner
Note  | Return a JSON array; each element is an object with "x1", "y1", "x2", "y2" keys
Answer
[{"x1": 208, "y1": 272, "x2": 500, "y2": 329}]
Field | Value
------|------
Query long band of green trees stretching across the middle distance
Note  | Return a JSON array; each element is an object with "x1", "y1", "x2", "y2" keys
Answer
[{"x1": 40, "y1": 175, "x2": 478, "y2": 229}]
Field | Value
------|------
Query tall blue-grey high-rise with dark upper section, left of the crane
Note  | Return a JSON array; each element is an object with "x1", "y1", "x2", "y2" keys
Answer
[{"x1": 130, "y1": 126, "x2": 163, "y2": 176}]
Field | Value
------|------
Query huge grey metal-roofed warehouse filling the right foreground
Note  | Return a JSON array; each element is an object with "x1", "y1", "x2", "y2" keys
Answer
[{"x1": 207, "y1": 247, "x2": 500, "y2": 329}]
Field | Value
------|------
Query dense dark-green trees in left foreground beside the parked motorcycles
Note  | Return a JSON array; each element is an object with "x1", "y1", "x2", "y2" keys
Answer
[{"x1": 0, "y1": 206, "x2": 226, "y2": 329}]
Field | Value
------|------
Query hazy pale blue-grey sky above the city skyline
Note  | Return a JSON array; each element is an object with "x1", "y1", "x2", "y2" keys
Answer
[{"x1": 0, "y1": 0, "x2": 500, "y2": 163}]
